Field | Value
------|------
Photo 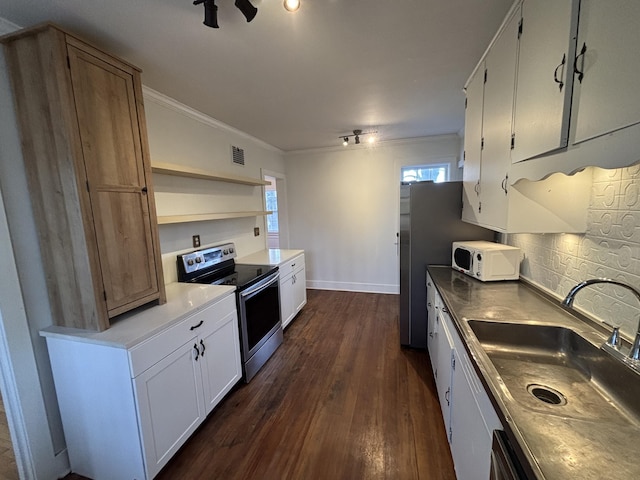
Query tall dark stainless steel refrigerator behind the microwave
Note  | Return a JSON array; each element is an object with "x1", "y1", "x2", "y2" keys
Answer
[{"x1": 400, "y1": 182, "x2": 495, "y2": 348}]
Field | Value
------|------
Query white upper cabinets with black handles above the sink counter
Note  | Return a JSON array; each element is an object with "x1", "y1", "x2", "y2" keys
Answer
[{"x1": 463, "y1": 0, "x2": 640, "y2": 186}]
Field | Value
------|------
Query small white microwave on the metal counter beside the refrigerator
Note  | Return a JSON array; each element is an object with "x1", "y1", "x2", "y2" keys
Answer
[{"x1": 451, "y1": 241, "x2": 521, "y2": 282}]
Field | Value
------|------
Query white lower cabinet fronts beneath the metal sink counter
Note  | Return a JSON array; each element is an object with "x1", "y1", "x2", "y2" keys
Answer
[{"x1": 427, "y1": 287, "x2": 502, "y2": 480}]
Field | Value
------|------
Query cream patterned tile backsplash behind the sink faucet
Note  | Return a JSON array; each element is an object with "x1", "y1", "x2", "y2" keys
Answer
[{"x1": 503, "y1": 165, "x2": 640, "y2": 338}]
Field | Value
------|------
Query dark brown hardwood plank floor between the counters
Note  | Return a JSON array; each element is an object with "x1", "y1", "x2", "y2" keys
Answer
[{"x1": 68, "y1": 290, "x2": 455, "y2": 480}]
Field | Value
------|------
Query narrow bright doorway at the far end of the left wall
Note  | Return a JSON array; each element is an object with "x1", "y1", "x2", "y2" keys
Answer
[{"x1": 262, "y1": 170, "x2": 289, "y2": 248}]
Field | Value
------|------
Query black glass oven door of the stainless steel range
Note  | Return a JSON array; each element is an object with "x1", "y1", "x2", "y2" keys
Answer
[{"x1": 238, "y1": 271, "x2": 282, "y2": 363}]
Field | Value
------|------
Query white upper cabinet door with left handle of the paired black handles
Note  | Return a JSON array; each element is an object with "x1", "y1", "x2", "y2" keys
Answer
[{"x1": 511, "y1": 0, "x2": 577, "y2": 162}]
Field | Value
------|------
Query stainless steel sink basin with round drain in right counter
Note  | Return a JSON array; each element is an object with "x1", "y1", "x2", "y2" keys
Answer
[{"x1": 468, "y1": 320, "x2": 640, "y2": 426}]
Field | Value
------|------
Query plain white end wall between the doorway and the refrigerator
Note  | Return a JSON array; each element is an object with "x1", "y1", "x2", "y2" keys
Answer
[{"x1": 285, "y1": 135, "x2": 461, "y2": 293}]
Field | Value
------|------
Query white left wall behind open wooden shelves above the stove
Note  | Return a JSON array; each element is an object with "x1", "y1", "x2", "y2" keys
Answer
[{"x1": 145, "y1": 88, "x2": 285, "y2": 283}]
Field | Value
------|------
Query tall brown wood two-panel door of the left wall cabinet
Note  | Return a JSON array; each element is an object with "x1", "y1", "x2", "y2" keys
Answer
[{"x1": 68, "y1": 41, "x2": 159, "y2": 316}]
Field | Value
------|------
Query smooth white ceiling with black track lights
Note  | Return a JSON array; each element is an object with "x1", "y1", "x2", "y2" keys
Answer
[{"x1": 0, "y1": 0, "x2": 513, "y2": 151}]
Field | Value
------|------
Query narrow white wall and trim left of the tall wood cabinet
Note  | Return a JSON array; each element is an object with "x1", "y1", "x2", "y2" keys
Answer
[{"x1": 0, "y1": 18, "x2": 68, "y2": 480}]
